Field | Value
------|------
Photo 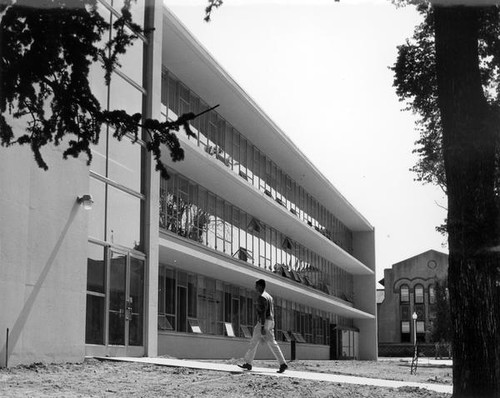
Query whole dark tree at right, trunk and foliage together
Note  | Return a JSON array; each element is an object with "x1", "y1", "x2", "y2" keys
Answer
[{"x1": 394, "y1": 4, "x2": 500, "y2": 398}]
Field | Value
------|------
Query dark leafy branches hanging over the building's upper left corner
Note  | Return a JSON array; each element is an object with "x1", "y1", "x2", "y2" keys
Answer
[{"x1": 0, "y1": 0, "x2": 203, "y2": 176}]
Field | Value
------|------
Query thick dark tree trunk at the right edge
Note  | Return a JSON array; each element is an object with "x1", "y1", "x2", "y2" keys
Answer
[{"x1": 434, "y1": 6, "x2": 500, "y2": 398}]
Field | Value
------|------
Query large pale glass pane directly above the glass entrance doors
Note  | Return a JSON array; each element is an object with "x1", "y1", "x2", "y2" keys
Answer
[{"x1": 107, "y1": 186, "x2": 142, "y2": 250}]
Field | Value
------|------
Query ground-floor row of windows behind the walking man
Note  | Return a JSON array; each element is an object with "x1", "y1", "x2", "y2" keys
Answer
[{"x1": 158, "y1": 264, "x2": 346, "y2": 344}]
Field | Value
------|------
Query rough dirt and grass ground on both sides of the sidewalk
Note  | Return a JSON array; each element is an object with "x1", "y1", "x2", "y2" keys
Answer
[{"x1": 0, "y1": 359, "x2": 451, "y2": 398}]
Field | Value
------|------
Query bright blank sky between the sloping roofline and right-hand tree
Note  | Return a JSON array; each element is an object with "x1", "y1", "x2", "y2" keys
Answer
[{"x1": 164, "y1": 0, "x2": 448, "y2": 288}]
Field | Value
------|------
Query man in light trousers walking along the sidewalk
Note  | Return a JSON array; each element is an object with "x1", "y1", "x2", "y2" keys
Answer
[{"x1": 238, "y1": 279, "x2": 288, "y2": 373}]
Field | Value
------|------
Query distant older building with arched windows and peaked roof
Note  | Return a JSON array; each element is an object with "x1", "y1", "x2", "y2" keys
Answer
[{"x1": 377, "y1": 250, "x2": 448, "y2": 344}]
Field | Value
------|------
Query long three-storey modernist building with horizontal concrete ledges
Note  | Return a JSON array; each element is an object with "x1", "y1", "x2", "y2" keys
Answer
[{"x1": 0, "y1": 0, "x2": 377, "y2": 366}]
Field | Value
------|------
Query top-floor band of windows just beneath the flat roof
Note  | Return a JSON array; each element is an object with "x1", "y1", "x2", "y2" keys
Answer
[{"x1": 160, "y1": 70, "x2": 353, "y2": 253}]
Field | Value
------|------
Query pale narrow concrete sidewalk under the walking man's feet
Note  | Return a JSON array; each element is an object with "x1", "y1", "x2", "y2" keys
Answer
[{"x1": 94, "y1": 357, "x2": 453, "y2": 394}]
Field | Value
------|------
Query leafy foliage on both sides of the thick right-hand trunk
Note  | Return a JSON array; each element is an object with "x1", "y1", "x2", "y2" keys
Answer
[{"x1": 391, "y1": 2, "x2": 500, "y2": 196}]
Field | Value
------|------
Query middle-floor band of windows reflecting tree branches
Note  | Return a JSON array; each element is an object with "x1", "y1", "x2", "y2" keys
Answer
[{"x1": 158, "y1": 173, "x2": 354, "y2": 302}]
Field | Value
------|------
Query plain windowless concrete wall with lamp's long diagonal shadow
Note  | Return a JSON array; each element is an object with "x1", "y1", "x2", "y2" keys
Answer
[{"x1": 0, "y1": 141, "x2": 88, "y2": 366}]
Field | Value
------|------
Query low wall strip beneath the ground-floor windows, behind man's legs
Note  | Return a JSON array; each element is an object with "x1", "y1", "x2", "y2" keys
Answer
[{"x1": 158, "y1": 332, "x2": 330, "y2": 361}]
